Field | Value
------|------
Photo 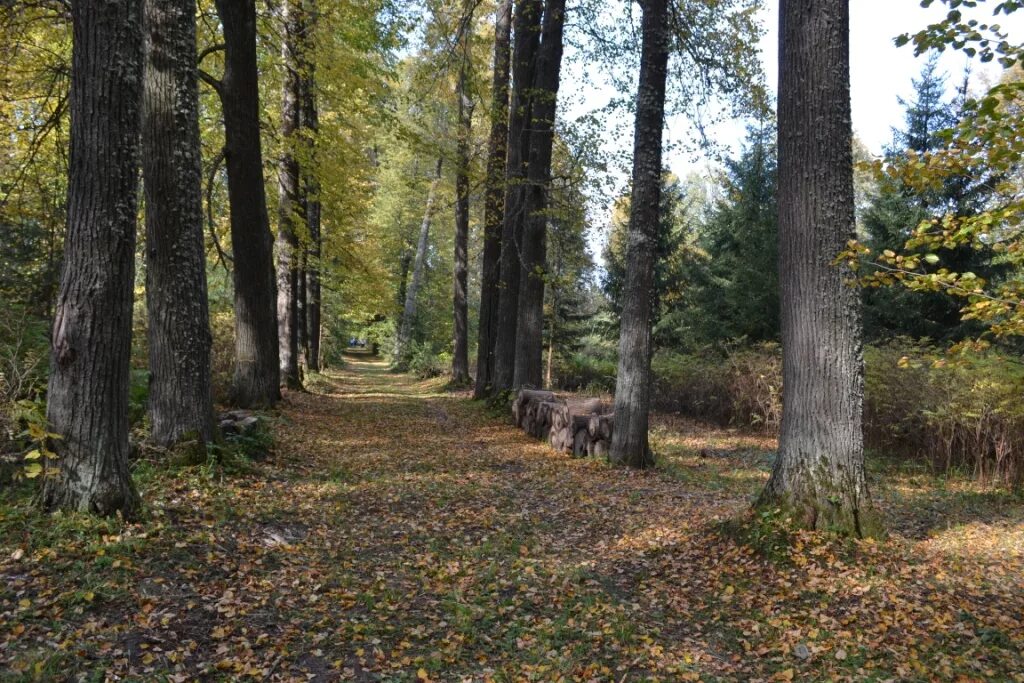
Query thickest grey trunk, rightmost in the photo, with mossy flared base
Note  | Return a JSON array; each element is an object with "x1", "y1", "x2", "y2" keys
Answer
[{"x1": 760, "y1": 0, "x2": 876, "y2": 536}]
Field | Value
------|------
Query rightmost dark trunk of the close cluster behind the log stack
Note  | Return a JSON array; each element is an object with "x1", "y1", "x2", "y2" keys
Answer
[{"x1": 512, "y1": 0, "x2": 565, "y2": 389}]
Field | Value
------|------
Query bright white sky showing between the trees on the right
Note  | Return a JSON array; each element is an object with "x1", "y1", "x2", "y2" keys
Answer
[{"x1": 564, "y1": 0, "x2": 1024, "y2": 259}]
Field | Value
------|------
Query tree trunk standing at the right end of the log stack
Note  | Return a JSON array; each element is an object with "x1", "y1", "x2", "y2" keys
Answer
[{"x1": 608, "y1": 0, "x2": 669, "y2": 467}]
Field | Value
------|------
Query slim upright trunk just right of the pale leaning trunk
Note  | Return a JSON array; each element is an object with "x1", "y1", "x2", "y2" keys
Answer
[{"x1": 452, "y1": 25, "x2": 473, "y2": 386}]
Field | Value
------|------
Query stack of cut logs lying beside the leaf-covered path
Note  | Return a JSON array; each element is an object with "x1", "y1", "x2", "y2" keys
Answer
[{"x1": 512, "y1": 389, "x2": 615, "y2": 458}]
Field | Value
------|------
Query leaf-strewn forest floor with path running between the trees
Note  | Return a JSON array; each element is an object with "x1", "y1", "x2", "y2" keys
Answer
[{"x1": 0, "y1": 358, "x2": 1024, "y2": 682}]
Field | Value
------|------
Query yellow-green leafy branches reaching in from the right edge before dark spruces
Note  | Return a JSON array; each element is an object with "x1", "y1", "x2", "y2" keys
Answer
[{"x1": 842, "y1": 0, "x2": 1024, "y2": 337}]
